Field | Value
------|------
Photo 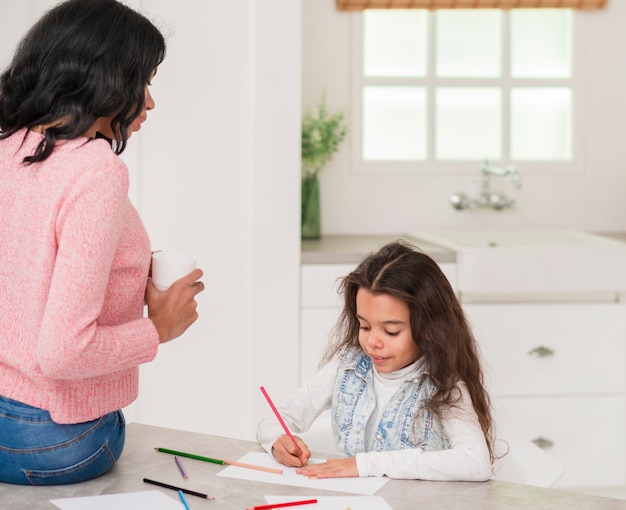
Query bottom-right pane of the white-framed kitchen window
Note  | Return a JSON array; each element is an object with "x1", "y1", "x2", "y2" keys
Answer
[{"x1": 511, "y1": 87, "x2": 572, "y2": 160}]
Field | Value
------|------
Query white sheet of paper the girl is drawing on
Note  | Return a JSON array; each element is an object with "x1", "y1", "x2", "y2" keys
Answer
[{"x1": 217, "y1": 452, "x2": 389, "y2": 496}]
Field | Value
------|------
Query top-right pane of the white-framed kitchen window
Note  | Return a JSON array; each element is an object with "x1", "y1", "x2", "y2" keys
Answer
[{"x1": 511, "y1": 9, "x2": 573, "y2": 78}]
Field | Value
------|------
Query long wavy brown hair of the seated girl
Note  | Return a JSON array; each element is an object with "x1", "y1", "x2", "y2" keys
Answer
[{"x1": 323, "y1": 241, "x2": 494, "y2": 462}]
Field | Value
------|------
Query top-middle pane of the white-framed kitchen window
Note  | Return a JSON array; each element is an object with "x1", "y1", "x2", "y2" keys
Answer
[{"x1": 436, "y1": 9, "x2": 502, "y2": 78}]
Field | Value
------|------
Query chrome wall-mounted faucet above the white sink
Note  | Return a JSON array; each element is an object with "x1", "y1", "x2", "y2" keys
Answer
[{"x1": 450, "y1": 160, "x2": 522, "y2": 211}]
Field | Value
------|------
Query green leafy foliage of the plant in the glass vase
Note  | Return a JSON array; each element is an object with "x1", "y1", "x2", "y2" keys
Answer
[{"x1": 302, "y1": 93, "x2": 348, "y2": 177}]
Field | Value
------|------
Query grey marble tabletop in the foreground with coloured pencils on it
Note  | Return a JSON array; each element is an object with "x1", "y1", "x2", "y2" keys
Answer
[{"x1": 0, "y1": 423, "x2": 626, "y2": 510}]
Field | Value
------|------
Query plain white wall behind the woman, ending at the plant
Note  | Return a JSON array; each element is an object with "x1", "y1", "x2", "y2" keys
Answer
[{"x1": 0, "y1": 0, "x2": 301, "y2": 439}]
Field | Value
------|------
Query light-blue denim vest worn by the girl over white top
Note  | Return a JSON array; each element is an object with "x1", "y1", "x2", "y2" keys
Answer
[{"x1": 332, "y1": 351, "x2": 450, "y2": 456}]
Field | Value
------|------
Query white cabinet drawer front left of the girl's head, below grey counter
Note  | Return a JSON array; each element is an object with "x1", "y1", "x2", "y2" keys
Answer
[{"x1": 300, "y1": 264, "x2": 356, "y2": 307}]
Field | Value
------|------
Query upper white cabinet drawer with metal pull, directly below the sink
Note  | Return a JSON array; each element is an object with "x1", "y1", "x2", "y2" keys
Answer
[{"x1": 464, "y1": 303, "x2": 626, "y2": 396}]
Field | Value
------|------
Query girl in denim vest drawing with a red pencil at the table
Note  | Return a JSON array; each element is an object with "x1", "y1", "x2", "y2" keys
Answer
[{"x1": 257, "y1": 241, "x2": 493, "y2": 481}]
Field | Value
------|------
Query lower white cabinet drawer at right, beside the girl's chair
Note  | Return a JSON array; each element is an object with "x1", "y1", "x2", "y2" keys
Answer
[{"x1": 500, "y1": 395, "x2": 626, "y2": 488}]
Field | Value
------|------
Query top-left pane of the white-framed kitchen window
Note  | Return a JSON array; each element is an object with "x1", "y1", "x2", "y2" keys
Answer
[{"x1": 363, "y1": 9, "x2": 428, "y2": 77}]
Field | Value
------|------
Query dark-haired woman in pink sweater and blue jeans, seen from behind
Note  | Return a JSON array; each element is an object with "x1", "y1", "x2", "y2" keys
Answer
[{"x1": 0, "y1": 0, "x2": 204, "y2": 485}]
